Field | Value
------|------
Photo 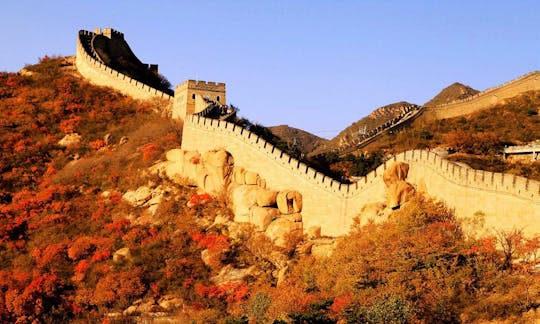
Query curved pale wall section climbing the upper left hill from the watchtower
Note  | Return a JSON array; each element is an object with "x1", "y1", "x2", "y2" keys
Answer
[{"x1": 75, "y1": 30, "x2": 173, "y2": 103}]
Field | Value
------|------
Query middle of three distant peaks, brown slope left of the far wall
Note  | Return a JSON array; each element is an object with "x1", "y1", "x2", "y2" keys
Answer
[{"x1": 311, "y1": 101, "x2": 412, "y2": 155}]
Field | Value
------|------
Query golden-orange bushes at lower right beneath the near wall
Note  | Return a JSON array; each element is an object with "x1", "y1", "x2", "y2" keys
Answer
[{"x1": 235, "y1": 197, "x2": 540, "y2": 323}]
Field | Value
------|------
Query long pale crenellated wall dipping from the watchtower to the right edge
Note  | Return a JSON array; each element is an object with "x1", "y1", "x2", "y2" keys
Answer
[{"x1": 182, "y1": 114, "x2": 540, "y2": 236}]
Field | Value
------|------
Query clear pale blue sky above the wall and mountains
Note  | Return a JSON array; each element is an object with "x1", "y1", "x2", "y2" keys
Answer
[{"x1": 0, "y1": 0, "x2": 540, "y2": 138}]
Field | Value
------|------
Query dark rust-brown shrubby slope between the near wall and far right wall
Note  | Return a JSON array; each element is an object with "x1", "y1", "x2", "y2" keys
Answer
[{"x1": 365, "y1": 91, "x2": 540, "y2": 180}]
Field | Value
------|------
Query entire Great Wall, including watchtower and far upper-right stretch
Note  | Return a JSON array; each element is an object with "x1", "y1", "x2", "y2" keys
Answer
[{"x1": 76, "y1": 27, "x2": 540, "y2": 236}]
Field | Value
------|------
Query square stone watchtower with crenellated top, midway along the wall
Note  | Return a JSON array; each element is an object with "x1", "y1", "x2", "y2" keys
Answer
[{"x1": 172, "y1": 80, "x2": 227, "y2": 120}]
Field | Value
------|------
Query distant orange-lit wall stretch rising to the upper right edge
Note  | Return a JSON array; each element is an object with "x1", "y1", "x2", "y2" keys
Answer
[{"x1": 422, "y1": 71, "x2": 540, "y2": 120}]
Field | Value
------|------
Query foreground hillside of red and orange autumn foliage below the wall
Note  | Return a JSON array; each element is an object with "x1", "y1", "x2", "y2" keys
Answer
[{"x1": 0, "y1": 57, "x2": 540, "y2": 323}]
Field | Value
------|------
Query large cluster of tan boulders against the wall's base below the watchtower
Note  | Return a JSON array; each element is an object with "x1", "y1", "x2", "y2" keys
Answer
[{"x1": 159, "y1": 149, "x2": 303, "y2": 247}]
